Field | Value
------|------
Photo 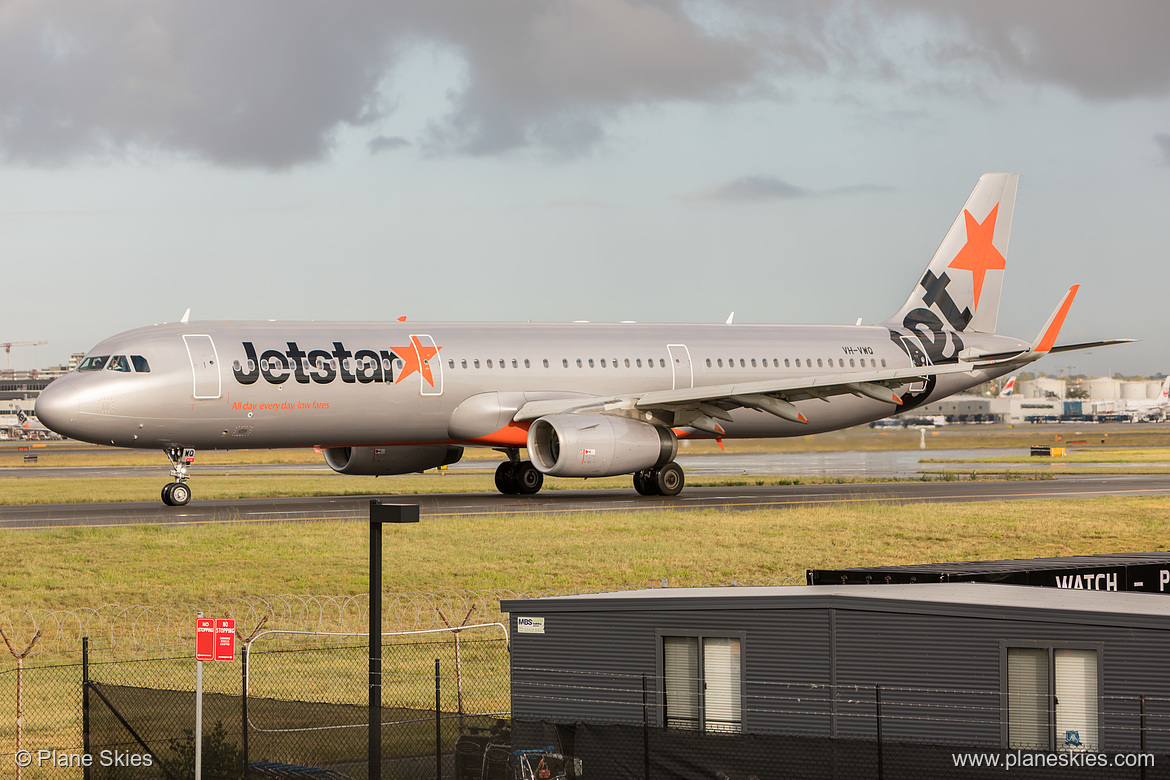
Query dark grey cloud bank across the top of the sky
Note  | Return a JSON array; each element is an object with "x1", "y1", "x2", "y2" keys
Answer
[{"x1": 0, "y1": 0, "x2": 1170, "y2": 168}]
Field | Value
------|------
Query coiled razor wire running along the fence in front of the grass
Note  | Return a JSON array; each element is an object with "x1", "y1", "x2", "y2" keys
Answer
[{"x1": 0, "y1": 577, "x2": 804, "y2": 658}]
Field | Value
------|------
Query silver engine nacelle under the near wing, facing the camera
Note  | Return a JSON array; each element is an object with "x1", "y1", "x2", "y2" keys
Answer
[{"x1": 528, "y1": 414, "x2": 679, "y2": 477}]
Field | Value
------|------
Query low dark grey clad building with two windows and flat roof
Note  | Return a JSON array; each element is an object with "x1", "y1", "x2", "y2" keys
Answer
[{"x1": 501, "y1": 582, "x2": 1170, "y2": 753}]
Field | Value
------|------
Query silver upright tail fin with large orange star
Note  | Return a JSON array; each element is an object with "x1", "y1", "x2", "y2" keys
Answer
[{"x1": 886, "y1": 173, "x2": 1019, "y2": 333}]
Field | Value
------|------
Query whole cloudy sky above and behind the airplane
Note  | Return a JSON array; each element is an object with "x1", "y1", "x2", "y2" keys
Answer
[{"x1": 0, "y1": 0, "x2": 1170, "y2": 375}]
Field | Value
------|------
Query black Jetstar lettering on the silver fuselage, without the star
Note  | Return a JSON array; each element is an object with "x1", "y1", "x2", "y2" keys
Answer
[{"x1": 232, "y1": 341, "x2": 402, "y2": 385}]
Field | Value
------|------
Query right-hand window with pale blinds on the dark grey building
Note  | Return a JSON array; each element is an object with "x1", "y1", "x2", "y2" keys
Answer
[{"x1": 1006, "y1": 647, "x2": 1101, "y2": 751}]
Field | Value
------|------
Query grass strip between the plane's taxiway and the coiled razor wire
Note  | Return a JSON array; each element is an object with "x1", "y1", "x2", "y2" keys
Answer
[{"x1": 0, "y1": 496, "x2": 1170, "y2": 612}]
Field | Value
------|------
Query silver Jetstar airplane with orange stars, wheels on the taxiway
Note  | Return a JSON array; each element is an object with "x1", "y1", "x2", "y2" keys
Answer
[{"x1": 36, "y1": 173, "x2": 1133, "y2": 506}]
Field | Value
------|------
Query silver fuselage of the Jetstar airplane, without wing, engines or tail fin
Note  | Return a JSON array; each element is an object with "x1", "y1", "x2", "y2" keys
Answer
[{"x1": 40, "y1": 322, "x2": 1026, "y2": 449}]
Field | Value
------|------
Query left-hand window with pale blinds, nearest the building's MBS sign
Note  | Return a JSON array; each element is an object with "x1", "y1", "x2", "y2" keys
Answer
[{"x1": 662, "y1": 636, "x2": 743, "y2": 733}]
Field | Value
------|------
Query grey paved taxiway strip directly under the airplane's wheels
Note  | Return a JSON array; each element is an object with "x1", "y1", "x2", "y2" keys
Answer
[{"x1": 0, "y1": 475, "x2": 1170, "y2": 531}]
